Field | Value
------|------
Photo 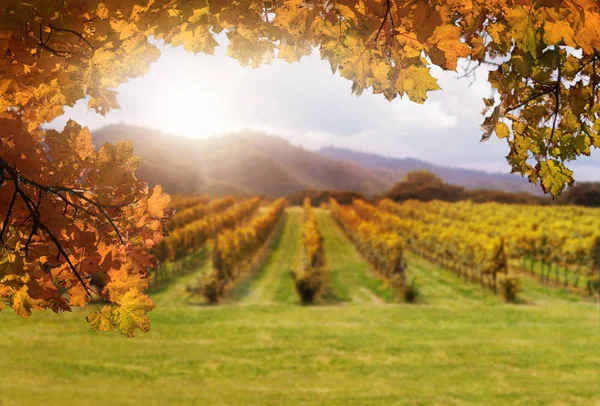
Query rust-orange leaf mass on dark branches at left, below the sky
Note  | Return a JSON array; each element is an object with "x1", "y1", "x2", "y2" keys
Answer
[{"x1": 0, "y1": 119, "x2": 170, "y2": 335}]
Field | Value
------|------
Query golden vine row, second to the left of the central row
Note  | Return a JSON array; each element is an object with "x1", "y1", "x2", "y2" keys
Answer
[{"x1": 155, "y1": 197, "x2": 260, "y2": 261}]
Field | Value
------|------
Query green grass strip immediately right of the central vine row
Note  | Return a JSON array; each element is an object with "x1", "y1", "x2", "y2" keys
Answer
[{"x1": 315, "y1": 210, "x2": 397, "y2": 302}]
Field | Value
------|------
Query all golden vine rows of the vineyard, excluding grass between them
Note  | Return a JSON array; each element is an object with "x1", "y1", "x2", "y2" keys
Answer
[{"x1": 144, "y1": 196, "x2": 600, "y2": 304}]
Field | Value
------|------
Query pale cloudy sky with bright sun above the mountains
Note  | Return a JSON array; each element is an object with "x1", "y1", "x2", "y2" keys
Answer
[{"x1": 48, "y1": 40, "x2": 600, "y2": 181}]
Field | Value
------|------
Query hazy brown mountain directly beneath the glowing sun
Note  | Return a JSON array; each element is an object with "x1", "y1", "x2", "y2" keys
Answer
[{"x1": 93, "y1": 124, "x2": 393, "y2": 196}]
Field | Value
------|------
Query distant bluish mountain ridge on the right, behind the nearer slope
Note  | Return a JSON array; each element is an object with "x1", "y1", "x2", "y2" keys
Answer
[{"x1": 319, "y1": 147, "x2": 541, "y2": 194}]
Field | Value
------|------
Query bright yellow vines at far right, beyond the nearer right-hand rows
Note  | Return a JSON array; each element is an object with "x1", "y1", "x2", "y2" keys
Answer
[{"x1": 382, "y1": 201, "x2": 600, "y2": 274}]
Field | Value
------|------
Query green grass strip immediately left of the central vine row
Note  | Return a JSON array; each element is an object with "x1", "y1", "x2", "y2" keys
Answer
[{"x1": 240, "y1": 208, "x2": 302, "y2": 305}]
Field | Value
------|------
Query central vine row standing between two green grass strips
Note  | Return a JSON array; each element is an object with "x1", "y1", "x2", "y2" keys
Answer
[{"x1": 292, "y1": 197, "x2": 327, "y2": 303}]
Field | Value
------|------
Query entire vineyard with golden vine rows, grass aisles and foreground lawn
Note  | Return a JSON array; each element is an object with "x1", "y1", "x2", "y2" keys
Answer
[{"x1": 0, "y1": 196, "x2": 600, "y2": 405}]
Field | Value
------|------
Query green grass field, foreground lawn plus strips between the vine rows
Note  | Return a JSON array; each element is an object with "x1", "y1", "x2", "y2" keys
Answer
[{"x1": 0, "y1": 209, "x2": 600, "y2": 406}]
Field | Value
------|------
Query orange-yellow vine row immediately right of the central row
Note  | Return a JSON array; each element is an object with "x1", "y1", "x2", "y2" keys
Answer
[{"x1": 330, "y1": 199, "x2": 405, "y2": 280}]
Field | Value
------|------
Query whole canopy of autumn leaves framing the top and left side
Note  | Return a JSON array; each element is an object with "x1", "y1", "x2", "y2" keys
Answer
[{"x1": 0, "y1": 0, "x2": 600, "y2": 334}]
